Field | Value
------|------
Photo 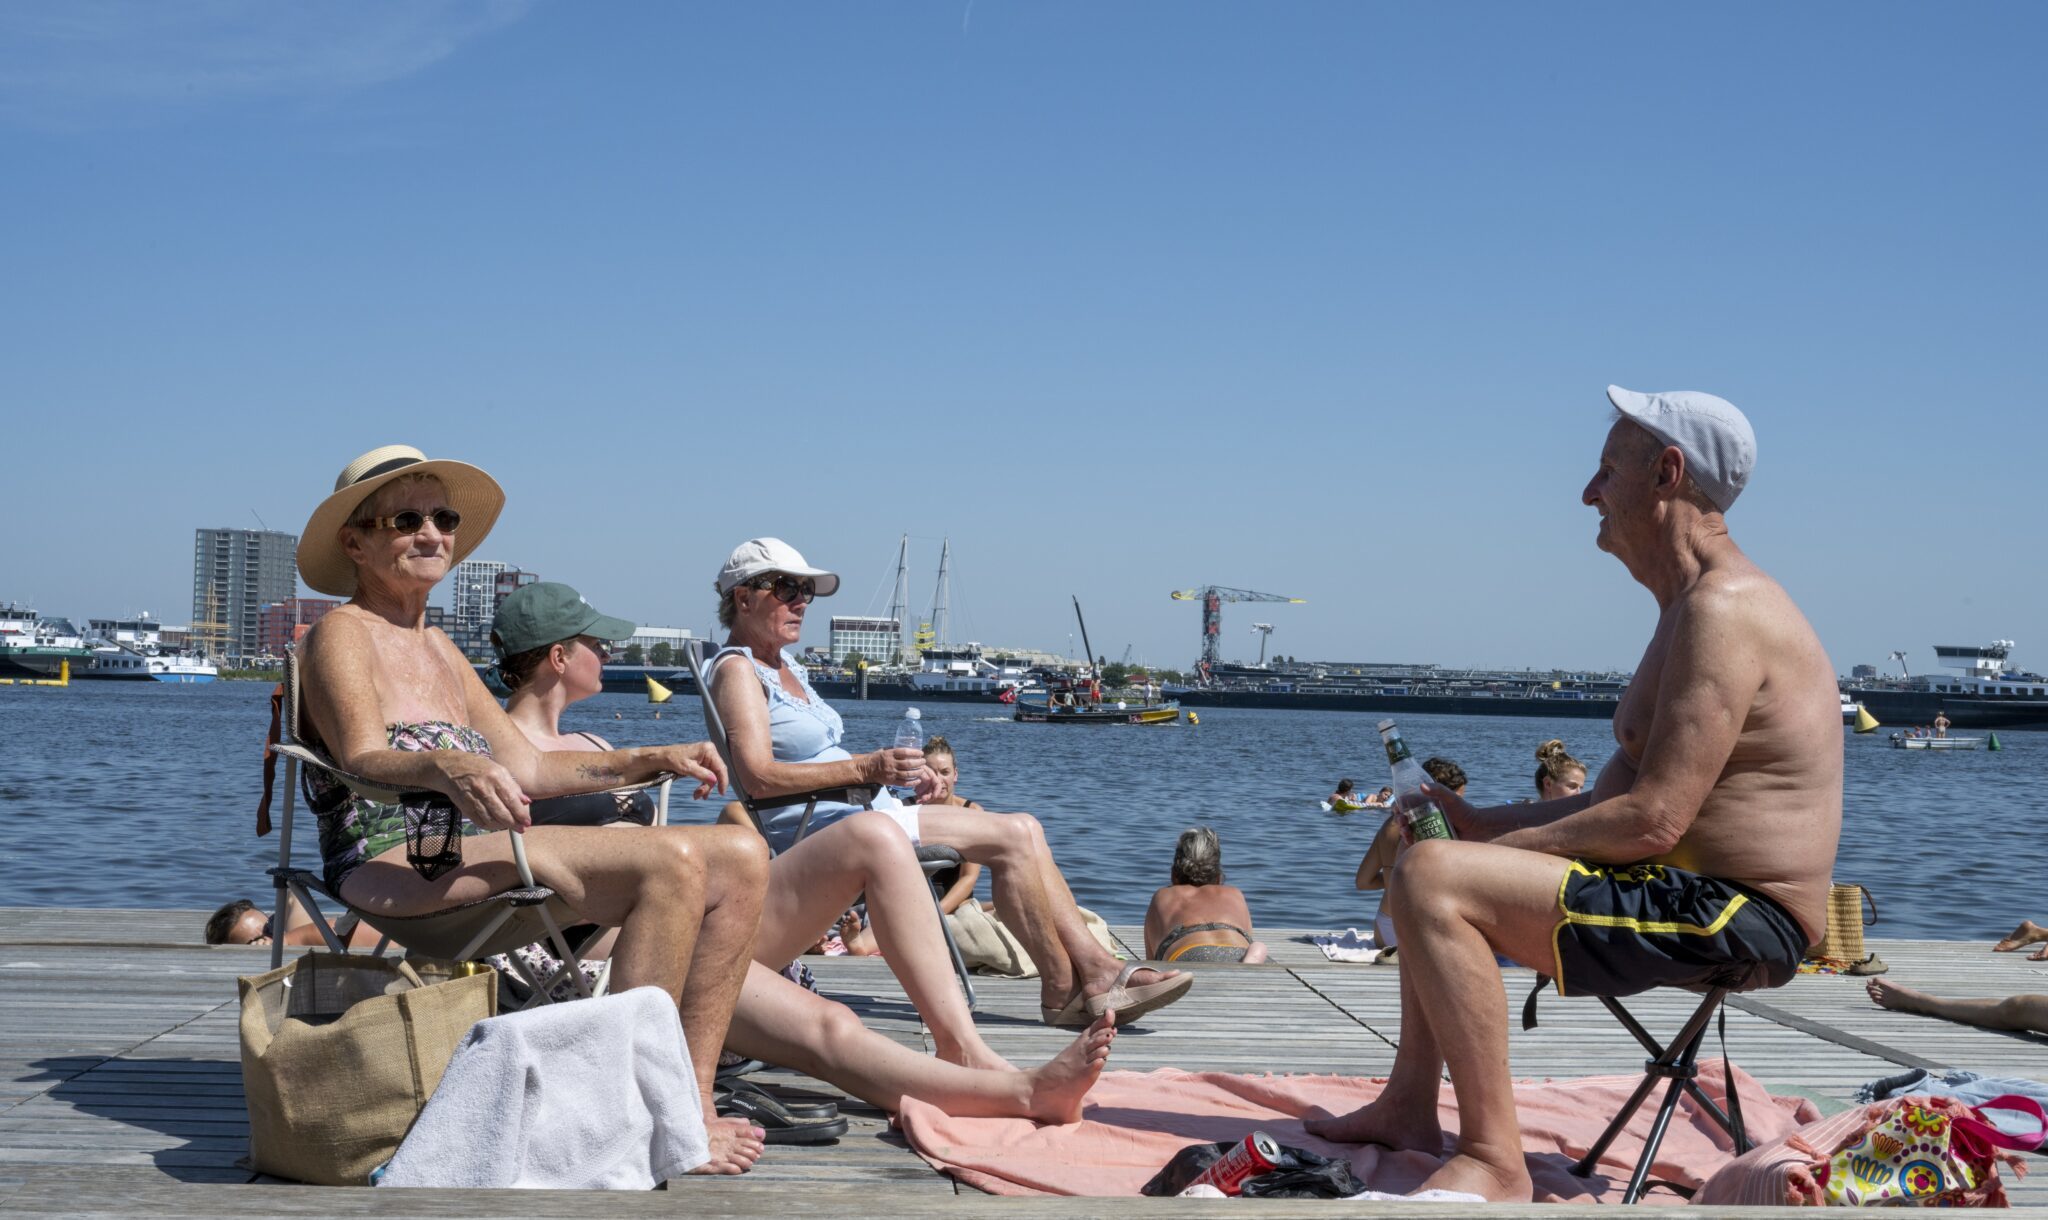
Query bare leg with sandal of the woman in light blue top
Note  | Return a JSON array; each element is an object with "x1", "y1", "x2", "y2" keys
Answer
[{"x1": 918, "y1": 804, "x2": 1180, "y2": 1009}]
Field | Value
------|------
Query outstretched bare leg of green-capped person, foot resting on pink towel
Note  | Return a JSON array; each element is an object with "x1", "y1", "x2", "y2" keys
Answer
[{"x1": 731, "y1": 962, "x2": 1116, "y2": 1122}]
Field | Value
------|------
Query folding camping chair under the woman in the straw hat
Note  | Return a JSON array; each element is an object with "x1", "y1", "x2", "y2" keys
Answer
[{"x1": 256, "y1": 651, "x2": 674, "y2": 1003}]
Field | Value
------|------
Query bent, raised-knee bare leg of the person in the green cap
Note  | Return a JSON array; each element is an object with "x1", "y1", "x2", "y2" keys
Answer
[{"x1": 754, "y1": 813, "x2": 1014, "y2": 1071}]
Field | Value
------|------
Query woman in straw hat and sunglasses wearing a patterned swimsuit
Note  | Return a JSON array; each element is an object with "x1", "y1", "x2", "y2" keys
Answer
[{"x1": 299, "y1": 444, "x2": 768, "y2": 1173}]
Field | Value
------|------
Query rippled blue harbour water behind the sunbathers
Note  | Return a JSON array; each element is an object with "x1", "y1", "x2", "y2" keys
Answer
[{"x1": 0, "y1": 682, "x2": 2048, "y2": 938}]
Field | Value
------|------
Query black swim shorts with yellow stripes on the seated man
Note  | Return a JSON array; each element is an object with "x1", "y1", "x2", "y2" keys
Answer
[{"x1": 1550, "y1": 860, "x2": 1806, "y2": 995}]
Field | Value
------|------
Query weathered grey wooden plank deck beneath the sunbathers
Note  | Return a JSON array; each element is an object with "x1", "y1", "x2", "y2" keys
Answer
[{"x1": 0, "y1": 909, "x2": 2048, "y2": 1216}]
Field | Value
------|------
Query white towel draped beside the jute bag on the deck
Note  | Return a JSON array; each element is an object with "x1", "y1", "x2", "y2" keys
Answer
[{"x1": 377, "y1": 987, "x2": 711, "y2": 1189}]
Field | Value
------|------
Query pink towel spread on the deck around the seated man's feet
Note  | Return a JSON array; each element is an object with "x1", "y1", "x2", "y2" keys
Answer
[{"x1": 897, "y1": 1058, "x2": 1821, "y2": 1204}]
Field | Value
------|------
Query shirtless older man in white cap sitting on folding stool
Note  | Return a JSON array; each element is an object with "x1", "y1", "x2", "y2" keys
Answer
[{"x1": 1309, "y1": 387, "x2": 1841, "y2": 1200}]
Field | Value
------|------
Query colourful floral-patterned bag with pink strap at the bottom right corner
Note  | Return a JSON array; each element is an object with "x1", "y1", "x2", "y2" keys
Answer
[{"x1": 1815, "y1": 1093, "x2": 2048, "y2": 1208}]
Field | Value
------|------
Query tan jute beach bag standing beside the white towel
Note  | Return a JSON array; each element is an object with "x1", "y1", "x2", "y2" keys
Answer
[{"x1": 238, "y1": 954, "x2": 498, "y2": 1185}]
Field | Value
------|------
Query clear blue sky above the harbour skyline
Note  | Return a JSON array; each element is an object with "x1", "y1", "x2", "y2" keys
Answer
[{"x1": 0, "y1": 0, "x2": 2048, "y2": 669}]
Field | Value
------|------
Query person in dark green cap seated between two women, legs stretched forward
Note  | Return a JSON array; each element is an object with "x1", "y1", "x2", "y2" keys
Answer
[{"x1": 492, "y1": 581, "x2": 1116, "y2": 1126}]
